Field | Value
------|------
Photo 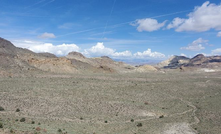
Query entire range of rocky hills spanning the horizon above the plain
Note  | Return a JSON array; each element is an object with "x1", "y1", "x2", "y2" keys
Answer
[{"x1": 0, "y1": 38, "x2": 221, "y2": 75}]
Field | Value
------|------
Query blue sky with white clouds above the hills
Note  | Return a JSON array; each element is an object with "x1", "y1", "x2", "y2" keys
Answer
[{"x1": 0, "y1": 0, "x2": 221, "y2": 61}]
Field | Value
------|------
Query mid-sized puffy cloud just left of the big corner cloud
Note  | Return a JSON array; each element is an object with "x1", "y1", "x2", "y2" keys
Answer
[{"x1": 131, "y1": 18, "x2": 166, "y2": 32}]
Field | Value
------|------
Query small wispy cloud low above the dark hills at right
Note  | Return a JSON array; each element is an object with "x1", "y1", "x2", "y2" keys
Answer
[{"x1": 180, "y1": 38, "x2": 209, "y2": 51}]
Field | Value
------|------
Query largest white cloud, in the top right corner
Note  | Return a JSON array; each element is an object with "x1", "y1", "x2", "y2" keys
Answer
[{"x1": 167, "y1": 1, "x2": 221, "y2": 32}]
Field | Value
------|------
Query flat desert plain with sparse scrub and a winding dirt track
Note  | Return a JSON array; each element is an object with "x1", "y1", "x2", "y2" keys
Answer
[{"x1": 0, "y1": 70, "x2": 221, "y2": 134}]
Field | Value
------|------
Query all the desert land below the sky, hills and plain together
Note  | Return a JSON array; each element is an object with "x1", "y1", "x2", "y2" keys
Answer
[{"x1": 0, "y1": 38, "x2": 221, "y2": 134}]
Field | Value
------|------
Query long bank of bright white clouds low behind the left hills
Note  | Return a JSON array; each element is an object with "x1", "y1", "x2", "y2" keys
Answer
[{"x1": 12, "y1": 40, "x2": 166, "y2": 59}]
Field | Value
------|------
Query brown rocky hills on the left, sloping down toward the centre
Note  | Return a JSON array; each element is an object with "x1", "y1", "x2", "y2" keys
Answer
[{"x1": 0, "y1": 38, "x2": 159, "y2": 75}]
